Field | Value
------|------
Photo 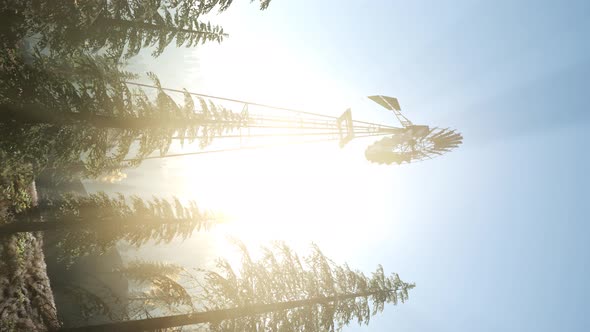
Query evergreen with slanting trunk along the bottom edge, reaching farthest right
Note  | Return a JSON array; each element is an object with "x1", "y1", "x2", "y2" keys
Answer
[{"x1": 59, "y1": 244, "x2": 414, "y2": 331}]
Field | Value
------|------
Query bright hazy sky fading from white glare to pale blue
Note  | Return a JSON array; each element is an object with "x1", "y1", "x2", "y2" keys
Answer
[{"x1": 86, "y1": 0, "x2": 590, "y2": 331}]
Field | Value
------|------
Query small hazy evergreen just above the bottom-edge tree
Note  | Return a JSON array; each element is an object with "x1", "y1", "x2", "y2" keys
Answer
[{"x1": 0, "y1": 193, "x2": 216, "y2": 260}]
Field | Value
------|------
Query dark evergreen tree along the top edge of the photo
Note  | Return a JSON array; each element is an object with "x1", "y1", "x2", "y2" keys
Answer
[{"x1": 11, "y1": 0, "x2": 270, "y2": 59}]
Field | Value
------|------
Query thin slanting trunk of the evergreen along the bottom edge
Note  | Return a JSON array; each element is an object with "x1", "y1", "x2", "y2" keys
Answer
[{"x1": 59, "y1": 289, "x2": 397, "y2": 332}]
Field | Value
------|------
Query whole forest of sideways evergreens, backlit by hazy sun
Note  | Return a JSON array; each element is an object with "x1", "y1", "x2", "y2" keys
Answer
[{"x1": 0, "y1": 0, "x2": 415, "y2": 331}]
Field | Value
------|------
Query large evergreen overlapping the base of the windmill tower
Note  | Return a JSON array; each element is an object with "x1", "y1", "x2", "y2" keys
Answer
[{"x1": 0, "y1": 53, "x2": 248, "y2": 177}]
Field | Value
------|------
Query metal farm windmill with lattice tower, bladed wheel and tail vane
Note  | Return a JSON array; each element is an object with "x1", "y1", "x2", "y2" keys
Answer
[{"x1": 131, "y1": 83, "x2": 463, "y2": 165}]
